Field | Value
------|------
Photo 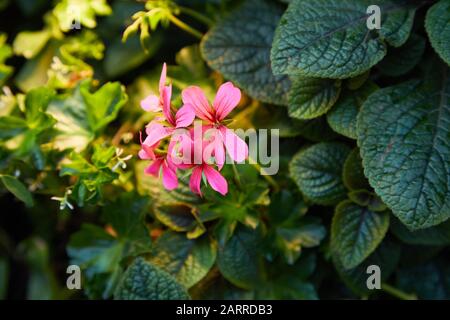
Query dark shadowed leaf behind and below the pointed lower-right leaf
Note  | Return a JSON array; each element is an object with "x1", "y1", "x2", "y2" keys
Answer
[{"x1": 332, "y1": 240, "x2": 401, "y2": 296}]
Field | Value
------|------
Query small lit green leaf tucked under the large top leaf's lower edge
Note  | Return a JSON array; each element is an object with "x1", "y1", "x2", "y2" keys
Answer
[{"x1": 288, "y1": 77, "x2": 341, "y2": 119}]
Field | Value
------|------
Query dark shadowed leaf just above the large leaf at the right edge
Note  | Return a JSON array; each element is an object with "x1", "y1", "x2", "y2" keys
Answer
[{"x1": 377, "y1": 34, "x2": 426, "y2": 77}]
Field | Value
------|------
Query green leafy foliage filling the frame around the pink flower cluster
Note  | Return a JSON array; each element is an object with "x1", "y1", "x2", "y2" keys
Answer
[{"x1": 0, "y1": 0, "x2": 450, "y2": 299}]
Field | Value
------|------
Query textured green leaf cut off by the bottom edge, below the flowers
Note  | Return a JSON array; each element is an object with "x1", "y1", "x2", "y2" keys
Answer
[{"x1": 114, "y1": 258, "x2": 189, "y2": 300}]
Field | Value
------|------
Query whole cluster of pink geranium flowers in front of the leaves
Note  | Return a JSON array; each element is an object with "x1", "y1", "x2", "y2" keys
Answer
[{"x1": 139, "y1": 64, "x2": 248, "y2": 195}]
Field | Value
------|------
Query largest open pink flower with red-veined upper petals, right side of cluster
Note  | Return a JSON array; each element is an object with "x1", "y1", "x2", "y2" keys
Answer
[{"x1": 182, "y1": 82, "x2": 248, "y2": 168}]
